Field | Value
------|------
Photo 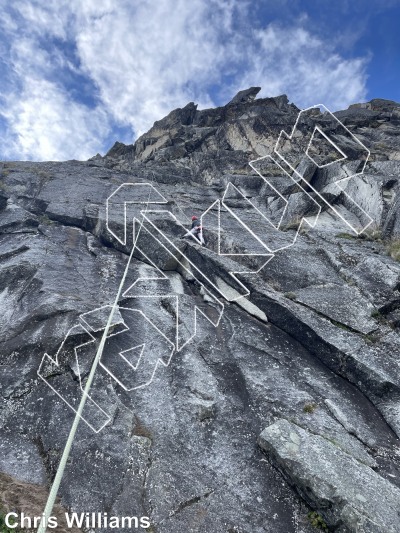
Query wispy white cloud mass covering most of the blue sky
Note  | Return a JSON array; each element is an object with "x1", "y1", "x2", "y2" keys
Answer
[{"x1": 0, "y1": 0, "x2": 366, "y2": 159}]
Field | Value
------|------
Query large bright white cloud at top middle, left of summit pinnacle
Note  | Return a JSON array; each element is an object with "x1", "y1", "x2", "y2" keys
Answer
[{"x1": 73, "y1": 0, "x2": 234, "y2": 133}]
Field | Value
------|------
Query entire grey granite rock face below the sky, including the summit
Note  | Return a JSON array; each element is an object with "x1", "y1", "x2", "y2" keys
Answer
[{"x1": 0, "y1": 87, "x2": 400, "y2": 533}]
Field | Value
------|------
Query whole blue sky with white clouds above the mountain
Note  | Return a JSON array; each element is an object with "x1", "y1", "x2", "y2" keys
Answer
[{"x1": 0, "y1": 0, "x2": 400, "y2": 161}]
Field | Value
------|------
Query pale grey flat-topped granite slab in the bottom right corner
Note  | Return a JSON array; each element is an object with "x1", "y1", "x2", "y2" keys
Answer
[{"x1": 259, "y1": 419, "x2": 400, "y2": 533}]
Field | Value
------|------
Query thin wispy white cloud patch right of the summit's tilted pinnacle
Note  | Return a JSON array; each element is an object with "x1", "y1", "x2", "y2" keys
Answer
[{"x1": 234, "y1": 24, "x2": 368, "y2": 111}]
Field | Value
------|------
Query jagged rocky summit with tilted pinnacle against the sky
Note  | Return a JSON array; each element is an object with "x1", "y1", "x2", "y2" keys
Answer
[{"x1": 106, "y1": 87, "x2": 299, "y2": 163}]
